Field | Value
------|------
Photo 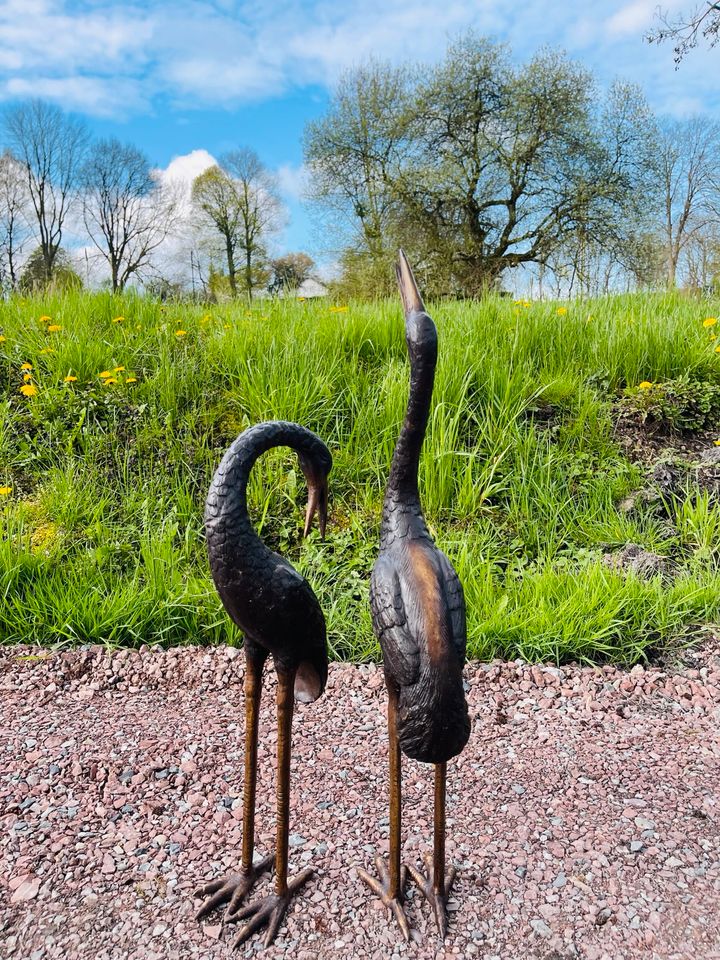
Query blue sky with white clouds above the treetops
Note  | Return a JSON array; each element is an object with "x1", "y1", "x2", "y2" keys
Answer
[{"x1": 0, "y1": 0, "x2": 720, "y2": 266}]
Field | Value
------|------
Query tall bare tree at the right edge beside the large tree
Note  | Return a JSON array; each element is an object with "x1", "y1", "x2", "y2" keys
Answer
[{"x1": 657, "y1": 117, "x2": 720, "y2": 287}]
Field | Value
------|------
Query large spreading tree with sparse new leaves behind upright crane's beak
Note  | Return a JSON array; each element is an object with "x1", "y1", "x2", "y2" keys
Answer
[{"x1": 306, "y1": 32, "x2": 660, "y2": 295}]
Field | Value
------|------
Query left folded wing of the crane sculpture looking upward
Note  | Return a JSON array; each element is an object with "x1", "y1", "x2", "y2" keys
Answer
[{"x1": 370, "y1": 556, "x2": 420, "y2": 687}]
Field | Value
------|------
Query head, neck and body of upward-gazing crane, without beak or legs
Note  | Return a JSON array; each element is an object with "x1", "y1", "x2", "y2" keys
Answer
[{"x1": 370, "y1": 284, "x2": 470, "y2": 763}]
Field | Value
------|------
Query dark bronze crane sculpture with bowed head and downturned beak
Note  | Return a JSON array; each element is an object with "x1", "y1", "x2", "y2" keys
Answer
[{"x1": 196, "y1": 420, "x2": 332, "y2": 947}]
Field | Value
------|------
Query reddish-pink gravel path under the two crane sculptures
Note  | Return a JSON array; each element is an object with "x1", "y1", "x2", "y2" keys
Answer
[{"x1": 0, "y1": 641, "x2": 720, "y2": 960}]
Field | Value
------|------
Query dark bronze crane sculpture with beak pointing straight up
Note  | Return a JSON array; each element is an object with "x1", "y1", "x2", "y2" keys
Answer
[{"x1": 360, "y1": 250, "x2": 470, "y2": 940}]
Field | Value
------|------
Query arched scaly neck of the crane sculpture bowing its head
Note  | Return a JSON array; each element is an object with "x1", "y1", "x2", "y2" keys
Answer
[{"x1": 205, "y1": 420, "x2": 325, "y2": 546}]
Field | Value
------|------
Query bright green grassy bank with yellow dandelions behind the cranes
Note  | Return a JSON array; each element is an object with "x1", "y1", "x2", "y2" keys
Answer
[{"x1": 0, "y1": 294, "x2": 720, "y2": 663}]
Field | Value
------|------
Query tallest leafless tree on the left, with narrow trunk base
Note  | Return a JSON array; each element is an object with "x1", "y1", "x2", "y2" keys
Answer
[{"x1": 5, "y1": 100, "x2": 87, "y2": 281}]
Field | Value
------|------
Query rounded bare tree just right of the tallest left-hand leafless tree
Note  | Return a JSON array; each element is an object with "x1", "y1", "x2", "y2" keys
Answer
[{"x1": 82, "y1": 139, "x2": 176, "y2": 292}]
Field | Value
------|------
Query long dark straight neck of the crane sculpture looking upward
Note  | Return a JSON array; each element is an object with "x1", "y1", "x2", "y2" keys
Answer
[{"x1": 385, "y1": 343, "x2": 437, "y2": 512}]
